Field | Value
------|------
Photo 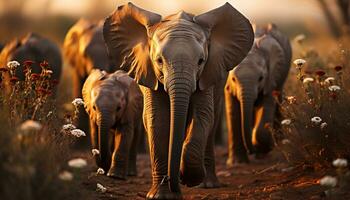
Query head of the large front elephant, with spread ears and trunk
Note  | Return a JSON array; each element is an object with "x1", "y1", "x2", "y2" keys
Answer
[{"x1": 103, "y1": 3, "x2": 254, "y2": 192}]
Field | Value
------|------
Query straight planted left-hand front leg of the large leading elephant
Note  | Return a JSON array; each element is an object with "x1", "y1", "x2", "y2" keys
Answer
[{"x1": 141, "y1": 87, "x2": 181, "y2": 199}]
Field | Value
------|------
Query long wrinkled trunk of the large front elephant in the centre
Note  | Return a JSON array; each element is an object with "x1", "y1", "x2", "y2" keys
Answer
[{"x1": 167, "y1": 72, "x2": 193, "y2": 192}]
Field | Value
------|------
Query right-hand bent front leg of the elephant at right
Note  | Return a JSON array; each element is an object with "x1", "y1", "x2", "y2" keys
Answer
[{"x1": 252, "y1": 96, "x2": 276, "y2": 158}]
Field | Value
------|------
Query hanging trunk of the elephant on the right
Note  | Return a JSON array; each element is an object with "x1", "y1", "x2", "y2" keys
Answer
[{"x1": 240, "y1": 90, "x2": 255, "y2": 153}]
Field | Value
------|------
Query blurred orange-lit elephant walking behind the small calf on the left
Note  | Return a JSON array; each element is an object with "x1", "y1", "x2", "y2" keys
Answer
[{"x1": 63, "y1": 19, "x2": 110, "y2": 136}]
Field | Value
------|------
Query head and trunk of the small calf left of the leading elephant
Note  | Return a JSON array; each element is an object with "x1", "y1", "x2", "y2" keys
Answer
[{"x1": 82, "y1": 69, "x2": 133, "y2": 170}]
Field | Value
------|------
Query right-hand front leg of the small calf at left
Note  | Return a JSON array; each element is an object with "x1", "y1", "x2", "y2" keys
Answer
[{"x1": 107, "y1": 123, "x2": 134, "y2": 180}]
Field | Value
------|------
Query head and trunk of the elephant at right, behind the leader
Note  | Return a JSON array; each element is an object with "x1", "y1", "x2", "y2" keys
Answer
[{"x1": 229, "y1": 32, "x2": 289, "y2": 153}]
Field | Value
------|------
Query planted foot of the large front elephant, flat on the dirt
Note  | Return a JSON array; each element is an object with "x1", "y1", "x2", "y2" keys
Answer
[{"x1": 146, "y1": 181, "x2": 182, "y2": 199}]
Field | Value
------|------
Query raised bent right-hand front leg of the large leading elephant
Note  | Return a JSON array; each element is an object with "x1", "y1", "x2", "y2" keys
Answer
[{"x1": 180, "y1": 88, "x2": 216, "y2": 187}]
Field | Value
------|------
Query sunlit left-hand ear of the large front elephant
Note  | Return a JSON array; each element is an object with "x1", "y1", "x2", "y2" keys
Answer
[{"x1": 103, "y1": 3, "x2": 161, "y2": 90}]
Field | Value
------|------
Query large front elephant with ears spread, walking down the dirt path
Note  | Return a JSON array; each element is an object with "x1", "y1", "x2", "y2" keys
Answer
[{"x1": 103, "y1": 3, "x2": 254, "y2": 199}]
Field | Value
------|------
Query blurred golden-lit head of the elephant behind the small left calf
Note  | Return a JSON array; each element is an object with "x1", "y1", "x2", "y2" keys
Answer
[{"x1": 63, "y1": 19, "x2": 109, "y2": 79}]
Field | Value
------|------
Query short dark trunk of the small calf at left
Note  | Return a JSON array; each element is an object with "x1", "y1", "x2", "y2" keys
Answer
[{"x1": 98, "y1": 111, "x2": 112, "y2": 170}]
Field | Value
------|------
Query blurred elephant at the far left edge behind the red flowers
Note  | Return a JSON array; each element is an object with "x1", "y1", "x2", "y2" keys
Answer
[{"x1": 0, "y1": 33, "x2": 62, "y2": 93}]
